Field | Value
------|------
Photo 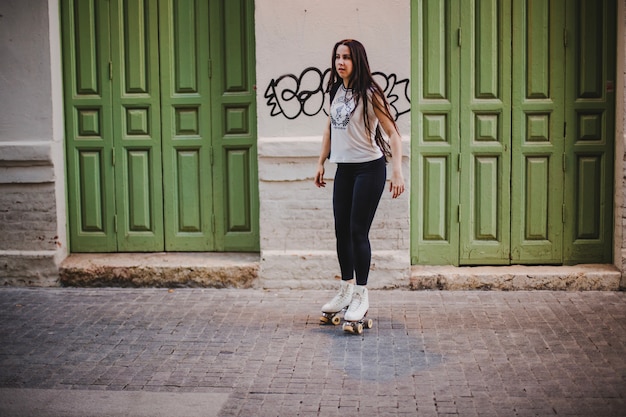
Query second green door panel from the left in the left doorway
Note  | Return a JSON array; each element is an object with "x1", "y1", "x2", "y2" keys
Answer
[{"x1": 110, "y1": 0, "x2": 164, "y2": 252}]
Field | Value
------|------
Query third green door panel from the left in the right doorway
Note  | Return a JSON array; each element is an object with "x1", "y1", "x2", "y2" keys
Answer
[{"x1": 511, "y1": 0, "x2": 566, "y2": 264}]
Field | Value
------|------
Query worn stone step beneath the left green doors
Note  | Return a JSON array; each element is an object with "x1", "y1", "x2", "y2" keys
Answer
[{"x1": 59, "y1": 252, "x2": 259, "y2": 288}]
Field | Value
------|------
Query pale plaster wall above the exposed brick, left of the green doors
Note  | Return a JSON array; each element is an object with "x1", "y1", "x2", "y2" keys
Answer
[{"x1": 0, "y1": 0, "x2": 53, "y2": 184}]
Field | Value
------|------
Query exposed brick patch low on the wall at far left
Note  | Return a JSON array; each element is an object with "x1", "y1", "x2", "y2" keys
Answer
[{"x1": 0, "y1": 183, "x2": 57, "y2": 251}]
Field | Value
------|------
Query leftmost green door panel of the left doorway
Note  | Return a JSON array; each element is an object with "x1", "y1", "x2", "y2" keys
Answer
[{"x1": 61, "y1": 0, "x2": 117, "y2": 252}]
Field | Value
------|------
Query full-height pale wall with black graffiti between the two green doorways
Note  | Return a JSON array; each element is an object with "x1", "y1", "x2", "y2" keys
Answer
[{"x1": 255, "y1": 0, "x2": 410, "y2": 287}]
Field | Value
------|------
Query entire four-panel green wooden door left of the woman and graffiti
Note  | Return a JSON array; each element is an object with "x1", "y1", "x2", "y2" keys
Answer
[{"x1": 61, "y1": 0, "x2": 258, "y2": 252}]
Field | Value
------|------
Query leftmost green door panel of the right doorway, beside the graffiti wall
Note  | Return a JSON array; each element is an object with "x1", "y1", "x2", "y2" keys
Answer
[{"x1": 411, "y1": 0, "x2": 460, "y2": 265}]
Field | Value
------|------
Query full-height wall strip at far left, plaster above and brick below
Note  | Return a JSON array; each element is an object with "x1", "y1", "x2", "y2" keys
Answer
[{"x1": 0, "y1": 0, "x2": 65, "y2": 285}]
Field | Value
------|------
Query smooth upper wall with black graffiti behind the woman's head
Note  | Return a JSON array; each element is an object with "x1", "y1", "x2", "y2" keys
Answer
[{"x1": 255, "y1": 0, "x2": 411, "y2": 138}]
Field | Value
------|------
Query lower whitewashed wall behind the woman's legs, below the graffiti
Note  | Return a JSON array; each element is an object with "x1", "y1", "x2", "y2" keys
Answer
[{"x1": 259, "y1": 135, "x2": 410, "y2": 288}]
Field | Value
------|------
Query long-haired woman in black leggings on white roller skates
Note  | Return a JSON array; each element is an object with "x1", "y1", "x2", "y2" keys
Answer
[{"x1": 315, "y1": 39, "x2": 404, "y2": 333}]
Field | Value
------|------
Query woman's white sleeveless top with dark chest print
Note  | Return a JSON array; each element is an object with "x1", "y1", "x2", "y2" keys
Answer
[{"x1": 330, "y1": 84, "x2": 383, "y2": 163}]
